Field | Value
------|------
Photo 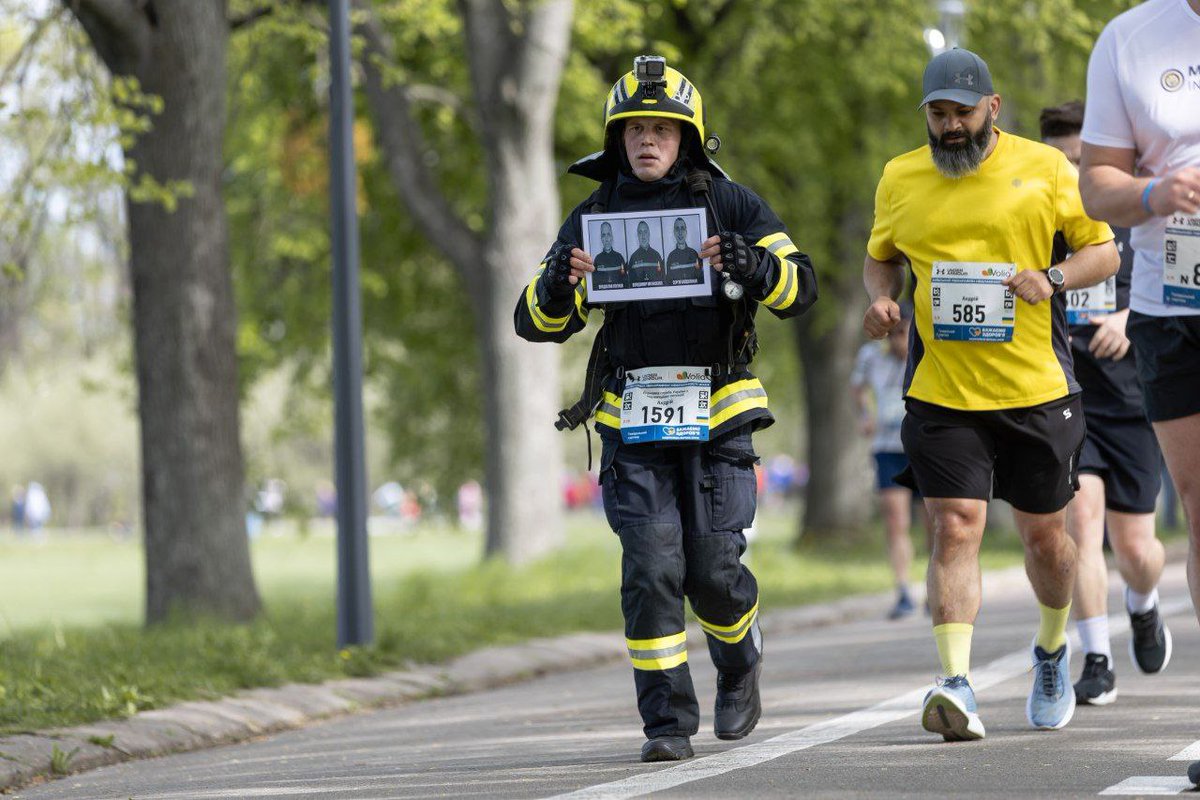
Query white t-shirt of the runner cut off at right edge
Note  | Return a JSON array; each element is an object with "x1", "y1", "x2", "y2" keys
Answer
[{"x1": 1082, "y1": 0, "x2": 1200, "y2": 317}]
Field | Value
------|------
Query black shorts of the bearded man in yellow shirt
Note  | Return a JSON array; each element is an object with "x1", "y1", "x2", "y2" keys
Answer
[{"x1": 896, "y1": 395, "x2": 1085, "y2": 513}]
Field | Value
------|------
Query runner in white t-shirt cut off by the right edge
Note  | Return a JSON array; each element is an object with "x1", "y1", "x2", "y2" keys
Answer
[{"x1": 1079, "y1": 0, "x2": 1200, "y2": 782}]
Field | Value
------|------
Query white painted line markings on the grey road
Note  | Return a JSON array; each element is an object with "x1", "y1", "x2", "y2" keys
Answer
[{"x1": 551, "y1": 599, "x2": 1192, "y2": 800}]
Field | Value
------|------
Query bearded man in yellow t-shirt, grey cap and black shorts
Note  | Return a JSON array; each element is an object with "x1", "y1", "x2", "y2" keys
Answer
[{"x1": 863, "y1": 49, "x2": 1120, "y2": 740}]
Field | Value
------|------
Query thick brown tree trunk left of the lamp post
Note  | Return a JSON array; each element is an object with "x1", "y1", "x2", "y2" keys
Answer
[{"x1": 61, "y1": 0, "x2": 259, "y2": 622}]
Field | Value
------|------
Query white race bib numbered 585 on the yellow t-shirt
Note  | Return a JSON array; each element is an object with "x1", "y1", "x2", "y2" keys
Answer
[{"x1": 930, "y1": 261, "x2": 1016, "y2": 342}]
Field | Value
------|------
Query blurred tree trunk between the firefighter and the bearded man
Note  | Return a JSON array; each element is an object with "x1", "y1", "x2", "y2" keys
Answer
[{"x1": 796, "y1": 219, "x2": 871, "y2": 540}]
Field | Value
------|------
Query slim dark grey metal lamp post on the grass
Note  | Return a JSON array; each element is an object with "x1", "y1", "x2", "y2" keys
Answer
[{"x1": 329, "y1": 0, "x2": 374, "y2": 648}]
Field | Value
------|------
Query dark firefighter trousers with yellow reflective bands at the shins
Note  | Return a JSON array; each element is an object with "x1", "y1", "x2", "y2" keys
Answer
[{"x1": 600, "y1": 426, "x2": 762, "y2": 738}]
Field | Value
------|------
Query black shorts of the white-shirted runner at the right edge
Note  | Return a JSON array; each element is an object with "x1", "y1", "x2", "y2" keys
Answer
[{"x1": 1126, "y1": 311, "x2": 1200, "y2": 422}]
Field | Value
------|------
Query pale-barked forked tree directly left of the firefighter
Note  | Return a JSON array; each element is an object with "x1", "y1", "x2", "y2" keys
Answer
[{"x1": 358, "y1": 0, "x2": 572, "y2": 563}]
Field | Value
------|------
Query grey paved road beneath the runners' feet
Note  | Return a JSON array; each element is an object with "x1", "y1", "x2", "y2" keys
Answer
[{"x1": 16, "y1": 565, "x2": 1200, "y2": 800}]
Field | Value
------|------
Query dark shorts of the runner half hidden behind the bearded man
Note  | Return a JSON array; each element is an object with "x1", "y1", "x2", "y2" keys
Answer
[{"x1": 1079, "y1": 416, "x2": 1163, "y2": 513}]
